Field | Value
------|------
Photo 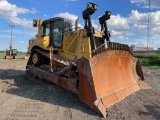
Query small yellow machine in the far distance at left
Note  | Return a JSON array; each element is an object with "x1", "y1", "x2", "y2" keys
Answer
[{"x1": 4, "y1": 40, "x2": 17, "y2": 59}]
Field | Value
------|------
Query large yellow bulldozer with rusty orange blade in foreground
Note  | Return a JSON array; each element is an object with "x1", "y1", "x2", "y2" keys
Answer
[{"x1": 26, "y1": 2, "x2": 147, "y2": 117}]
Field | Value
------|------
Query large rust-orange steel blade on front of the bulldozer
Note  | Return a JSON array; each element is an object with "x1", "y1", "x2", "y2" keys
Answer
[{"x1": 78, "y1": 50, "x2": 148, "y2": 117}]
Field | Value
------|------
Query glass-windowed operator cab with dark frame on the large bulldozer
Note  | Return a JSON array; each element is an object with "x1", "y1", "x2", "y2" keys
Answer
[{"x1": 41, "y1": 17, "x2": 72, "y2": 48}]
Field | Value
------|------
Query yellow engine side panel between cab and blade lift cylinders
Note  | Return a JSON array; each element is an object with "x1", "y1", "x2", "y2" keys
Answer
[{"x1": 60, "y1": 29, "x2": 91, "y2": 60}]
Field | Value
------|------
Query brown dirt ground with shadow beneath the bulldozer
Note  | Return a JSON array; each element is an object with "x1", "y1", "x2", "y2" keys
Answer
[{"x1": 0, "y1": 59, "x2": 160, "y2": 120}]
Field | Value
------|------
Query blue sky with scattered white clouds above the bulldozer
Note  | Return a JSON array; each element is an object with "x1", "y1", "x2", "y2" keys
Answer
[{"x1": 0, "y1": 0, "x2": 160, "y2": 51}]
